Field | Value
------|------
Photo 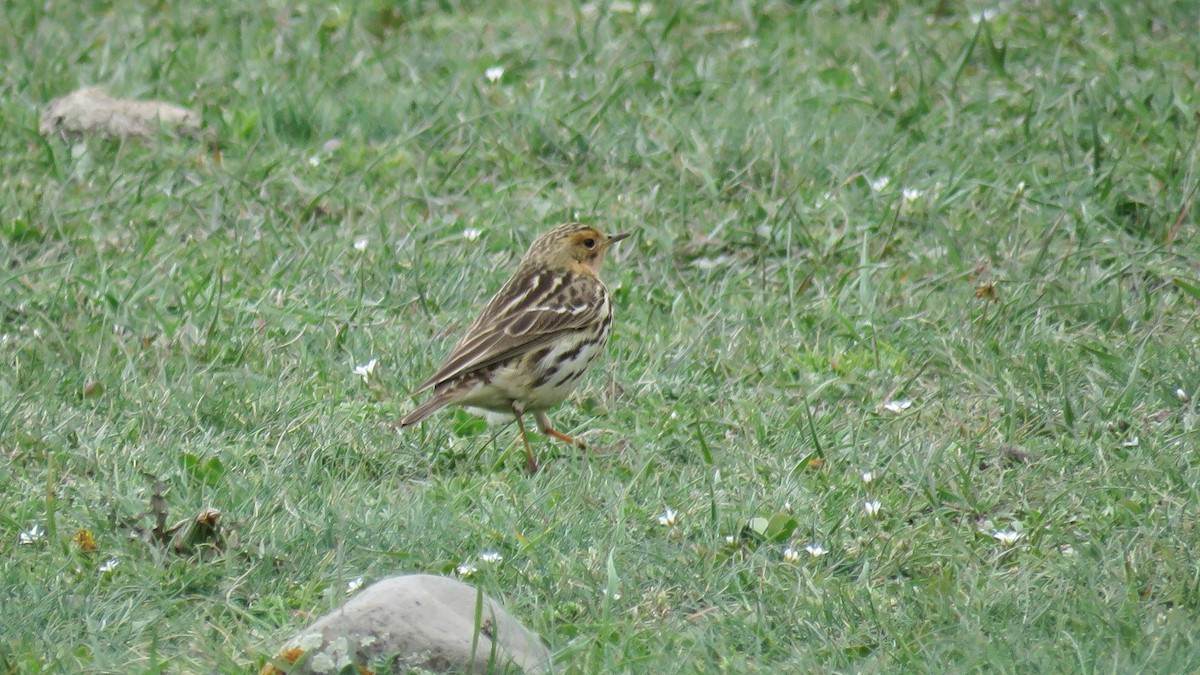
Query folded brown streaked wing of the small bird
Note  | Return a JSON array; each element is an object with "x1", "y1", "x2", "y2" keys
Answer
[{"x1": 413, "y1": 271, "x2": 606, "y2": 394}]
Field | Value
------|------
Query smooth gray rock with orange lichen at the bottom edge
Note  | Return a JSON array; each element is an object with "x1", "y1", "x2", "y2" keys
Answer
[{"x1": 263, "y1": 574, "x2": 550, "y2": 675}]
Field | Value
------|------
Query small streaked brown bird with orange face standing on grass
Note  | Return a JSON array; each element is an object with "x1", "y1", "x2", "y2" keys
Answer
[{"x1": 400, "y1": 222, "x2": 629, "y2": 473}]
